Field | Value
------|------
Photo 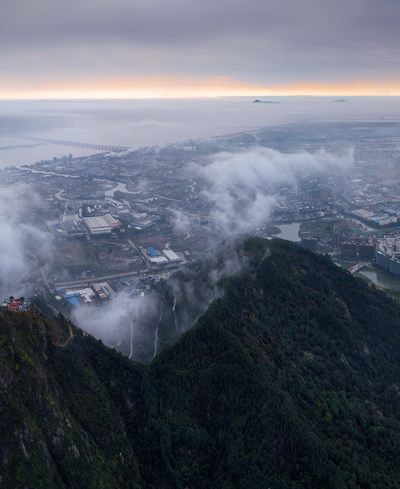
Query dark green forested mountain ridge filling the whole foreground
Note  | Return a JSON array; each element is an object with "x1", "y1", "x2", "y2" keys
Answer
[{"x1": 0, "y1": 238, "x2": 400, "y2": 489}]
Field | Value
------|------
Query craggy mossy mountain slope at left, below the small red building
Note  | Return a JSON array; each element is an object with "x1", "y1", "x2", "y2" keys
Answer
[{"x1": 0, "y1": 312, "x2": 139, "y2": 488}]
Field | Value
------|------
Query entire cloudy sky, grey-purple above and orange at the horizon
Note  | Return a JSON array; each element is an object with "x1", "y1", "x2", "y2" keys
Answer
[{"x1": 0, "y1": 0, "x2": 400, "y2": 99}]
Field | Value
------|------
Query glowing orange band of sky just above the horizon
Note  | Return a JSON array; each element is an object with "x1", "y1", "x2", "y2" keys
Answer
[{"x1": 0, "y1": 76, "x2": 400, "y2": 100}]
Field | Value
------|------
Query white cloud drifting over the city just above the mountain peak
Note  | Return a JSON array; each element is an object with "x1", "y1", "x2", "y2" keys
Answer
[{"x1": 200, "y1": 148, "x2": 353, "y2": 236}]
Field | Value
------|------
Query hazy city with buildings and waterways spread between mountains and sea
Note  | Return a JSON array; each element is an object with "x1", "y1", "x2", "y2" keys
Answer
[{"x1": 0, "y1": 120, "x2": 400, "y2": 315}]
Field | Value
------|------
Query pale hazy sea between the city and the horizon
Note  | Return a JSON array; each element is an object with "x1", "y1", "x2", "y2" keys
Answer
[{"x1": 0, "y1": 96, "x2": 400, "y2": 168}]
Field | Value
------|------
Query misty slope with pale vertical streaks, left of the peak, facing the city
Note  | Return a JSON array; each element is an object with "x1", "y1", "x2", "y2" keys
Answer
[{"x1": 95, "y1": 236, "x2": 252, "y2": 363}]
